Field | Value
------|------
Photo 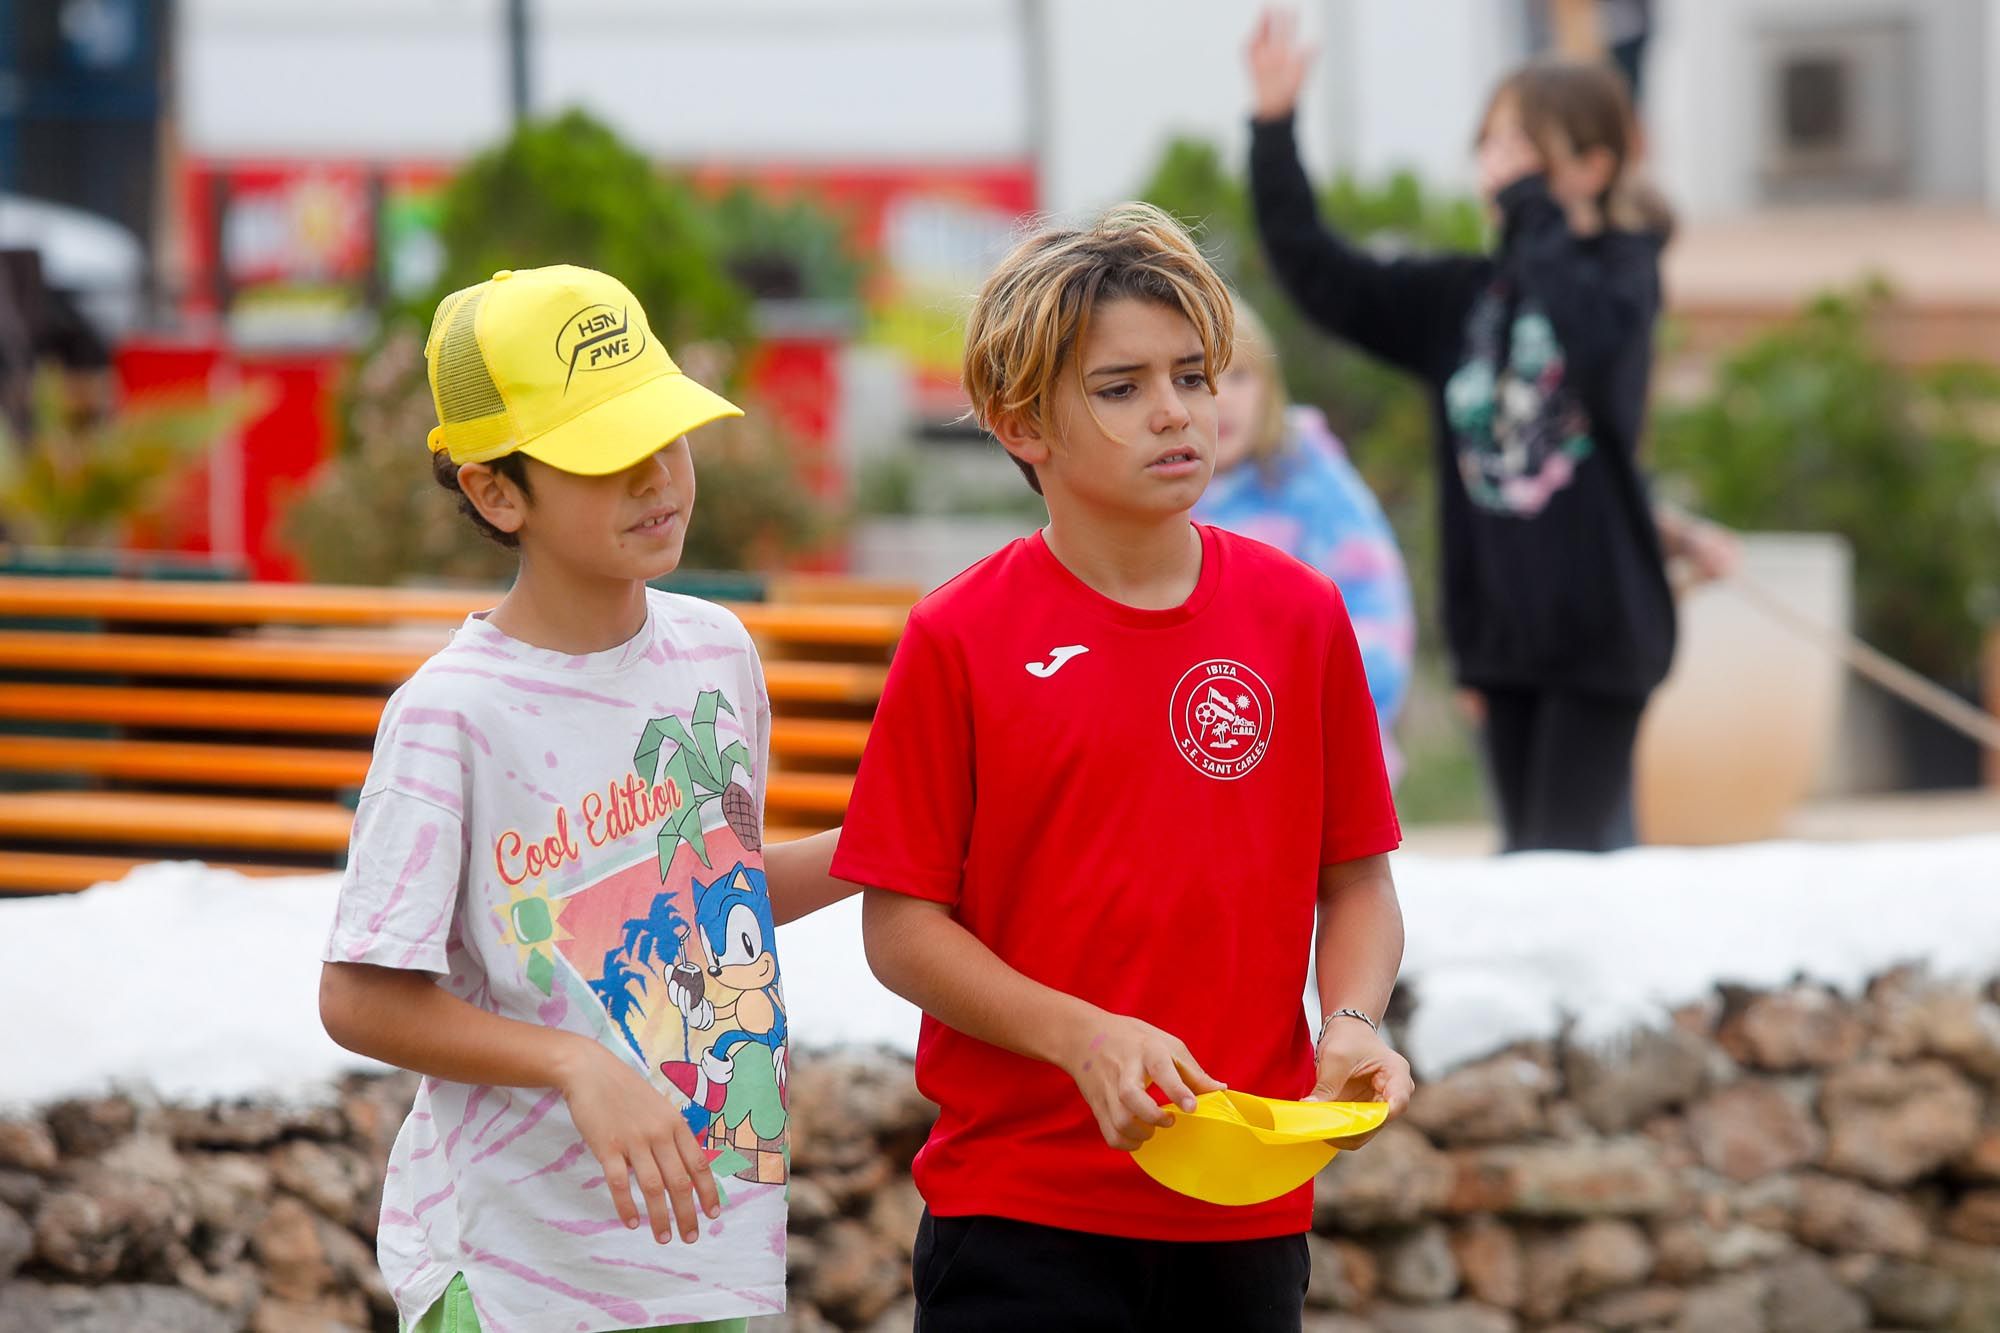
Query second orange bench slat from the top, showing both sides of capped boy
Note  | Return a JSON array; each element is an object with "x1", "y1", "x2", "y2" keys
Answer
[{"x1": 0, "y1": 636, "x2": 888, "y2": 704}]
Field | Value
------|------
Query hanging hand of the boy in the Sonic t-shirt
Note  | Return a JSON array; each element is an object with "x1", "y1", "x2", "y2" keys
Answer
[{"x1": 558, "y1": 1039, "x2": 722, "y2": 1245}]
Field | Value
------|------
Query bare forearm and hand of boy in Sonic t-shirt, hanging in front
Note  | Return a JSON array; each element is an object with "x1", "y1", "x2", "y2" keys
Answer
[{"x1": 320, "y1": 963, "x2": 720, "y2": 1243}]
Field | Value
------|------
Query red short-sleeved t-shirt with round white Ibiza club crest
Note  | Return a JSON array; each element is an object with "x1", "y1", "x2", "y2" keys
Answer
[{"x1": 832, "y1": 526, "x2": 1402, "y2": 1241}]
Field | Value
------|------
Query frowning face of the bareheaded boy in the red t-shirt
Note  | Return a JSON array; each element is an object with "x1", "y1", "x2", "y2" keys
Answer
[{"x1": 1010, "y1": 298, "x2": 1216, "y2": 516}]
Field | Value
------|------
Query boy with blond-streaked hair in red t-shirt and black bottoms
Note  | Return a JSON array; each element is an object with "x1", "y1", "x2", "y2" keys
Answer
[{"x1": 832, "y1": 204, "x2": 1410, "y2": 1333}]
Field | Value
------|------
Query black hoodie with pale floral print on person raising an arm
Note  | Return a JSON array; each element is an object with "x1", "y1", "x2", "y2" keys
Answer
[{"x1": 1250, "y1": 118, "x2": 1674, "y2": 697}]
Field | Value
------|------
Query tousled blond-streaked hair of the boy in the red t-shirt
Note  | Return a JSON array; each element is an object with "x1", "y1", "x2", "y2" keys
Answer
[{"x1": 964, "y1": 204, "x2": 1236, "y2": 494}]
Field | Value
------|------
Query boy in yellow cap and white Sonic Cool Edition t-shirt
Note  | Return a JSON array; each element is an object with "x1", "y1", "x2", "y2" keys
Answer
[{"x1": 320, "y1": 266, "x2": 844, "y2": 1333}]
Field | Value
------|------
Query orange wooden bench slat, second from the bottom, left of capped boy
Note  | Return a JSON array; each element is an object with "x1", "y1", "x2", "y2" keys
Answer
[{"x1": 0, "y1": 791, "x2": 352, "y2": 853}]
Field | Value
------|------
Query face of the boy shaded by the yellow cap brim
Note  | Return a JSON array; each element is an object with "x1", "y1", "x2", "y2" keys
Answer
[{"x1": 518, "y1": 436, "x2": 694, "y2": 578}]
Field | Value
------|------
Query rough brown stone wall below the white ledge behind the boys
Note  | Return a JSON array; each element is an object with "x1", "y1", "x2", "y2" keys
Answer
[{"x1": 0, "y1": 975, "x2": 2000, "y2": 1333}]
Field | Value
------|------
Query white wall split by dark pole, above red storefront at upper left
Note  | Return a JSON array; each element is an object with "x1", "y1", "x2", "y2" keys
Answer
[{"x1": 178, "y1": 0, "x2": 1026, "y2": 162}]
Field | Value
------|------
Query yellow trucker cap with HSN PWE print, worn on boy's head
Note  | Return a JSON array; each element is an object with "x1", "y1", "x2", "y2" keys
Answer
[{"x1": 424, "y1": 264, "x2": 742, "y2": 476}]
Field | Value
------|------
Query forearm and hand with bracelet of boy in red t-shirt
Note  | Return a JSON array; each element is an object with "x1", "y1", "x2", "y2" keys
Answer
[{"x1": 1308, "y1": 855, "x2": 1414, "y2": 1147}]
